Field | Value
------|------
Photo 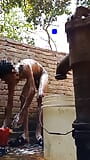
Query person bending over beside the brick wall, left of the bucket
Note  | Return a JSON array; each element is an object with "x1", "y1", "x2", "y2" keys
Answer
[{"x1": 0, "y1": 59, "x2": 48, "y2": 146}]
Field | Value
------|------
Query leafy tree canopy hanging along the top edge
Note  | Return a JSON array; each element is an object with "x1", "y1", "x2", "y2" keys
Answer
[{"x1": 1, "y1": 0, "x2": 90, "y2": 26}]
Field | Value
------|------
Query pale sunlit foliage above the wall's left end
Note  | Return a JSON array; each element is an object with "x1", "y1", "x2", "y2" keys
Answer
[{"x1": 0, "y1": 8, "x2": 34, "y2": 44}]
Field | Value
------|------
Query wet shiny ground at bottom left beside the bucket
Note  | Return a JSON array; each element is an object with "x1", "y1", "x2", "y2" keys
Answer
[{"x1": 0, "y1": 144, "x2": 45, "y2": 160}]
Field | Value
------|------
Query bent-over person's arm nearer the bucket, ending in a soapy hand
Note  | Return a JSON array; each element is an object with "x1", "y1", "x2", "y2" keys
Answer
[{"x1": 12, "y1": 65, "x2": 35, "y2": 127}]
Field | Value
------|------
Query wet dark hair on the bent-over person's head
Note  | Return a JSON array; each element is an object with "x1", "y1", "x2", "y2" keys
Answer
[{"x1": 0, "y1": 60, "x2": 14, "y2": 79}]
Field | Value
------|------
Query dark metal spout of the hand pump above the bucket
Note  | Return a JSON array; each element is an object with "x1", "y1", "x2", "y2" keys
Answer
[{"x1": 55, "y1": 55, "x2": 71, "y2": 80}]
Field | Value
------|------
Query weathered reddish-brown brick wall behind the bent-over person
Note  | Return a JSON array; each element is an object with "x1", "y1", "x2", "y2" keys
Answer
[{"x1": 0, "y1": 38, "x2": 73, "y2": 126}]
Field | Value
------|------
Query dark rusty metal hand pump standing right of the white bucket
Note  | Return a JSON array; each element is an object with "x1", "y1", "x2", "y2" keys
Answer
[{"x1": 56, "y1": 6, "x2": 90, "y2": 160}]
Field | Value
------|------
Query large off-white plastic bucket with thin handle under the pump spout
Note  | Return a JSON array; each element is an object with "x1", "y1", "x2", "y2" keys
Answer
[{"x1": 43, "y1": 95, "x2": 76, "y2": 160}]
